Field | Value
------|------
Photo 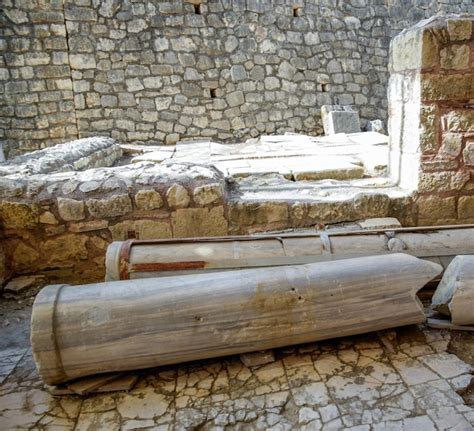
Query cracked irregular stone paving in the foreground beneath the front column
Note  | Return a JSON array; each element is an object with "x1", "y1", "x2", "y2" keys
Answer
[{"x1": 0, "y1": 301, "x2": 474, "y2": 431}]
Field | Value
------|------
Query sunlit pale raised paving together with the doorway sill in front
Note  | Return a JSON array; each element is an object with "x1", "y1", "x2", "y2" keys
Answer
[{"x1": 121, "y1": 132, "x2": 407, "y2": 212}]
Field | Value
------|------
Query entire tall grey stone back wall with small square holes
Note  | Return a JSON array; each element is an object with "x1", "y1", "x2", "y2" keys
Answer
[{"x1": 0, "y1": 0, "x2": 474, "y2": 155}]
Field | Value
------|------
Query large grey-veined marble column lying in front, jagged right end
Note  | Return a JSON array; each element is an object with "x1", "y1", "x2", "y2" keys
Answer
[{"x1": 31, "y1": 254, "x2": 442, "y2": 384}]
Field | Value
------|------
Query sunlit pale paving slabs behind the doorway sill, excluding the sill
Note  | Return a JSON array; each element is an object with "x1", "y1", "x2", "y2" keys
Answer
[{"x1": 132, "y1": 132, "x2": 388, "y2": 181}]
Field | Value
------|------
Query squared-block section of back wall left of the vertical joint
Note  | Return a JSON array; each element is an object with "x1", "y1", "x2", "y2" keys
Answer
[{"x1": 0, "y1": 0, "x2": 78, "y2": 159}]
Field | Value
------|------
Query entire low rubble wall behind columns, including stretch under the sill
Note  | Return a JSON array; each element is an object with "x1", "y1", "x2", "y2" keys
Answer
[{"x1": 0, "y1": 154, "x2": 410, "y2": 283}]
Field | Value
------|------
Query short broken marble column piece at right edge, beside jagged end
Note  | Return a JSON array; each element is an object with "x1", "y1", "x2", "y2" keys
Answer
[{"x1": 432, "y1": 256, "x2": 474, "y2": 325}]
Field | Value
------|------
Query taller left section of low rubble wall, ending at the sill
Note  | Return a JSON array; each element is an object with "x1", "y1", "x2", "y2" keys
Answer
[{"x1": 0, "y1": 164, "x2": 228, "y2": 282}]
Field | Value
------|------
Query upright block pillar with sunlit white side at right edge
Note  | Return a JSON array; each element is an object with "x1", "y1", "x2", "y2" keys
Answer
[{"x1": 389, "y1": 16, "x2": 474, "y2": 225}]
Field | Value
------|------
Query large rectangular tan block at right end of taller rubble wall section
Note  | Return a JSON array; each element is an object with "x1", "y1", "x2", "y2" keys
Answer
[{"x1": 171, "y1": 206, "x2": 228, "y2": 238}]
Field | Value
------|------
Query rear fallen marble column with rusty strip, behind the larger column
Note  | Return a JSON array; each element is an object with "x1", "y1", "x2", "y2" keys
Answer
[{"x1": 105, "y1": 225, "x2": 474, "y2": 281}]
